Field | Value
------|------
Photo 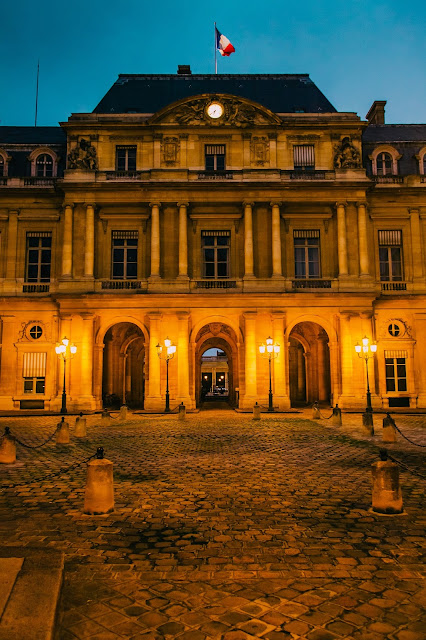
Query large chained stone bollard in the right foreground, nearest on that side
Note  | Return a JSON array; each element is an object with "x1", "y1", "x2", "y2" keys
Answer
[{"x1": 371, "y1": 449, "x2": 404, "y2": 514}]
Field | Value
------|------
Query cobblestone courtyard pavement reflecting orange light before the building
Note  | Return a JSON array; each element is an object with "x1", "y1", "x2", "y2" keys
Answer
[{"x1": 0, "y1": 410, "x2": 426, "y2": 640}]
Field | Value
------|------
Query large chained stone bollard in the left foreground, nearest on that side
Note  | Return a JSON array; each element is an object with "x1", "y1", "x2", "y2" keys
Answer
[{"x1": 84, "y1": 447, "x2": 114, "y2": 515}]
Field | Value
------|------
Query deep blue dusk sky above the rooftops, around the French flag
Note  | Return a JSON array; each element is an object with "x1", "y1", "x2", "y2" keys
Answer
[{"x1": 0, "y1": 0, "x2": 426, "y2": 125}]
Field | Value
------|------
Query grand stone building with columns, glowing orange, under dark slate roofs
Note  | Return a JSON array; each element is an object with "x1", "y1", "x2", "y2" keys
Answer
[{"x1": 0, "y1": 67, "x2": 426, "y2": 411}]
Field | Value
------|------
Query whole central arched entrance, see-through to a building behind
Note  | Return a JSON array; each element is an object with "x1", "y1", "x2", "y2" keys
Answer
[{"x1": 195, "y1": 323, "x2": 239, "y2": 406}]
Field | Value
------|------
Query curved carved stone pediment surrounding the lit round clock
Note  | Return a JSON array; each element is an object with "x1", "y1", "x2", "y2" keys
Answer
[{"x1": 149, "y1": 93, "x2": 281, "y2": 128}]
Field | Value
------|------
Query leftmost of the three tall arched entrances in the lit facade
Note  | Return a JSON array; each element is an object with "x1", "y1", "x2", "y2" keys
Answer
[{"x1": 102, "y1": 322, "x2": 145, "y2": 408}]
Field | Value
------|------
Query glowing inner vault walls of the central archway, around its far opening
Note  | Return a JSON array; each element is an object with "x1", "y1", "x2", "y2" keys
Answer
[{"x1": 194, "y1": 322, "x2": 239, "y2": 406}]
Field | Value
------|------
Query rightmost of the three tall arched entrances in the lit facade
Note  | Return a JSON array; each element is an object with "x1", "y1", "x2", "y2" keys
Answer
[{"x1": 289, "y1": 321, "x2": 331, "y2": 406}]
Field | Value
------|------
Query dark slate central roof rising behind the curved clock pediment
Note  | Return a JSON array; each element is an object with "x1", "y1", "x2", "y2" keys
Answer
[{"x1": 93, "y1": 74, "x2": 336, "y2": 113}]
